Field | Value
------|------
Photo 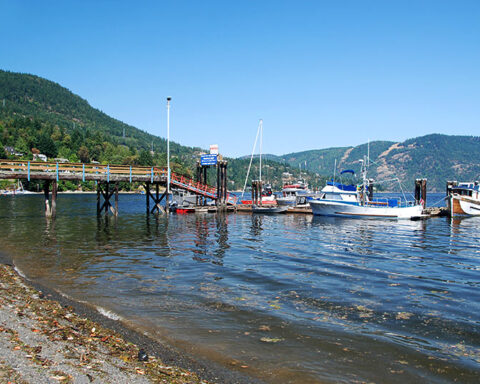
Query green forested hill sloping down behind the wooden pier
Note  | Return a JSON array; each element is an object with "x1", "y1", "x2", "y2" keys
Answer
[{"x1": 0, "y1": 70, "x2": 323, "y2": 190}]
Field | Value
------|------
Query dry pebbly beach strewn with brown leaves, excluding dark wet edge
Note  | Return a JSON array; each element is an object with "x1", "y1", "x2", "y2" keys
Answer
[{"x1": 0, "y1": 265, "x2": 214, "y2": 384}]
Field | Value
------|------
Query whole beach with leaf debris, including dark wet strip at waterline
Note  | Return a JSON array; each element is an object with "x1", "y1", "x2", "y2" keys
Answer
[{"x1": 0, "y1": 253, "x2": 259, "y2": 384}]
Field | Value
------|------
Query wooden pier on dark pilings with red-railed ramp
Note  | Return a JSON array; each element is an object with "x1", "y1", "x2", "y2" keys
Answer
[{"x1": 0, "y1": 160, "x2": 237, "y2": 217}]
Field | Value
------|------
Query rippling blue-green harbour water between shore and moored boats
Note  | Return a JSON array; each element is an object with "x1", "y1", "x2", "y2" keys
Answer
[{"x1": 0, "y1": 195, "x2": 480, "y2": 383}]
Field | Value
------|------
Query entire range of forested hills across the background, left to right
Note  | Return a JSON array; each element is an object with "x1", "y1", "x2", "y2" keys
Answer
[{"x1": 0, "y1": 70, "x2": 480, "y2": 191}]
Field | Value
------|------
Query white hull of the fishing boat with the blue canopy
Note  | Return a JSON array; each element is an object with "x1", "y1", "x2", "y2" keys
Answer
[{"x1": 309, "y1": 200, "x2": 423, "y2": 219}]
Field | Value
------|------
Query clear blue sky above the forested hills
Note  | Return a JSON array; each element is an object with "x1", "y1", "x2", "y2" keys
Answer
[{"x1": 0, "y1": 0, "x2": 480, "y2": 157}]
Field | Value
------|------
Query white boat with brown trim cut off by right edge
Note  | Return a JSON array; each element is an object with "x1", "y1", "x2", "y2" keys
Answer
[{"x1": 447, "y1": 181, "x2": 480, "y2": 216}]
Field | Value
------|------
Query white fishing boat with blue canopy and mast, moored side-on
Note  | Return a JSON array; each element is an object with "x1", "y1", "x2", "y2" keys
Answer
[{"x1": 307, "y1": 158, "x2": 423, "y2": 219}]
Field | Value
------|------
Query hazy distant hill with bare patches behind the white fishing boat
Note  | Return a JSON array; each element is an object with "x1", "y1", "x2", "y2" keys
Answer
[{"x1": 273, "y1": 134, "x2": 480, "y2": 192}]
